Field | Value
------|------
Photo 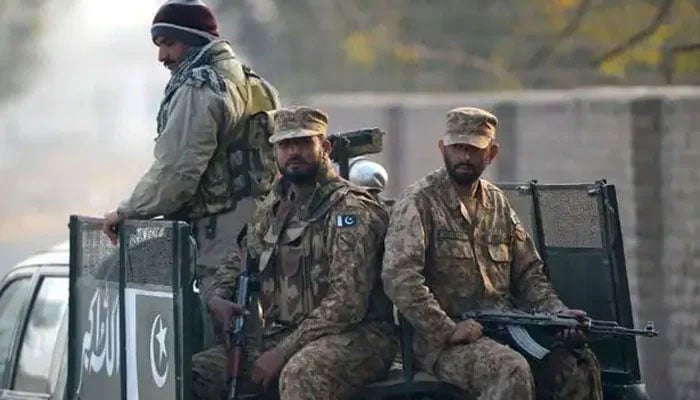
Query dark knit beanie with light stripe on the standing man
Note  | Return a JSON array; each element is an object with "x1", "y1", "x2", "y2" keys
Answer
[{"x1": 151, "y1": 0, "x2": 219, "y2": 46}]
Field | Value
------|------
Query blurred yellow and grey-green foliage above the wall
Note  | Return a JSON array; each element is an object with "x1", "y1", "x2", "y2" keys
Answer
[{"x1": 210, "y1": 0, "x2": 700, "y2": 94}]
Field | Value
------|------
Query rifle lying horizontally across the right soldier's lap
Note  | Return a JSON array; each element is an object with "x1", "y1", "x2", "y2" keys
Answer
[{"x1": 461, "y1": 311, "x2": 659, "y2": 360}]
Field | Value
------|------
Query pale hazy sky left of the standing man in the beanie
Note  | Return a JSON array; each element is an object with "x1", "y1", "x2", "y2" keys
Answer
[{"x1": 0, "y1": 0, "x2": 170, "y2": 266}]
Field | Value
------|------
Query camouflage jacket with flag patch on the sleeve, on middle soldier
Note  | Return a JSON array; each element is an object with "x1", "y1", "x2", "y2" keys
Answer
[{"x1": 213, "y1": 170, "x2": 393, "y2": 357}]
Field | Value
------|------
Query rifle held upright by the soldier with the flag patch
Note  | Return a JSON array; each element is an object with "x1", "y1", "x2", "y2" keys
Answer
[{"x1": 226, "y1": 251, "x2": 260, "y2": 400}]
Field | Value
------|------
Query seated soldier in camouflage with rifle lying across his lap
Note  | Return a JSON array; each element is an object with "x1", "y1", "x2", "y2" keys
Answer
[{"x1": 382, "y1": 107, "x2": 602, "y2": 400}]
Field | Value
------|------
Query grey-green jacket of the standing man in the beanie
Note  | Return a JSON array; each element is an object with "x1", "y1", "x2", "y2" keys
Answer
[{"x1": 118, "y1": 41, "x2": 266, "y2": 220}]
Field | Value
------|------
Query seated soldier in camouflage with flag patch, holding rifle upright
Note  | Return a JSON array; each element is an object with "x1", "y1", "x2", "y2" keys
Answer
[{"x1": 193, "y1": 107, "x2": 397, "y2": 400}]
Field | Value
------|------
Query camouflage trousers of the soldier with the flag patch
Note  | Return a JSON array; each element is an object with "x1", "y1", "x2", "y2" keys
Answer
[{"x1": 192, "y1": 323, "x2": 398, "y2": 400}]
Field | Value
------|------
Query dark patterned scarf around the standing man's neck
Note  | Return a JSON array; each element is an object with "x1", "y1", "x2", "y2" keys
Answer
[{"x1": 156, "y1": 40, "x2": 233, "y2": 139}]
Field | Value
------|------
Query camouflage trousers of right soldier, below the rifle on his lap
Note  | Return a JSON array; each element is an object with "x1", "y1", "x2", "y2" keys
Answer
[{"x1": 433, "y1": 337, "x2": 603, "y2": 400}]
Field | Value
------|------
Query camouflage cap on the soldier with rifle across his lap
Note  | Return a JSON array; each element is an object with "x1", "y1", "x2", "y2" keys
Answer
[{"x1": 443, "y1": 107, "x2": 498, "y2": 149}]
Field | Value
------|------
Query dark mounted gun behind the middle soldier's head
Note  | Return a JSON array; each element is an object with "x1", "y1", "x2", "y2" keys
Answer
[{"x1": 328, "y1": 128, "x2": 386, "y2": 179}]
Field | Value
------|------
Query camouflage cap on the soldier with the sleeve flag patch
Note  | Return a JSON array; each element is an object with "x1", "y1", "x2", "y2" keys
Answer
[{"x1": 269, "y1": 106, "x2": 328, "y2": 143}]
